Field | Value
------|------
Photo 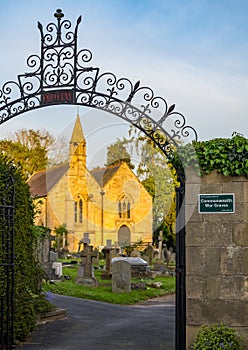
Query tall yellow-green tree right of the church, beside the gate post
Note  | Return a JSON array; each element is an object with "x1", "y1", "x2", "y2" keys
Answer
[{"x1": 129, "y1": 127, "x2": 178, "y2": 246}]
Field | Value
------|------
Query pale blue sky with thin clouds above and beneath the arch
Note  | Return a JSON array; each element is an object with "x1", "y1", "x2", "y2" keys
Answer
[{"x1": 0, "y1": 0, "x2": 248, "y2": 167}]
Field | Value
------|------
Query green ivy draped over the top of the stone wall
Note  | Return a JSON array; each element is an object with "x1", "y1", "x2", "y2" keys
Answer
[{"x1": 170, "y1": 134, "x2": 248, "y2": 178}]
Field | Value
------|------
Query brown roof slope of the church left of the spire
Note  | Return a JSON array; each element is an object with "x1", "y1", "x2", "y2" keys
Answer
[{"x1": 28, "y1": 164, "x2": 69, "y2": 197}]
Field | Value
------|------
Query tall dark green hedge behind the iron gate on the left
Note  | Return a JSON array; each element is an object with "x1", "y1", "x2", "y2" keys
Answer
[{"x1": 0, "y1": 156, "x2": 50, "y2": 340}]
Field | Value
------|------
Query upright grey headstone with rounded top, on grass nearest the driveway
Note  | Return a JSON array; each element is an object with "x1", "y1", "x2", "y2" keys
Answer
[{"x1": 112, "y1": 260, "x2": 131, "y2": 293}]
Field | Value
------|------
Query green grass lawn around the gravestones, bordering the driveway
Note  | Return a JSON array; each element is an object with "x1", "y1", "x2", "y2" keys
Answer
[{"x1": 43, "y1": 265, "x2": 175, "y2": 305}]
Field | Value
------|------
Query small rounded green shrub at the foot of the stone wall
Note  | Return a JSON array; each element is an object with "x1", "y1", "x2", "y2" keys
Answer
[{"x1": 191, "y1": 324, "x2": 242, "y2": 350}]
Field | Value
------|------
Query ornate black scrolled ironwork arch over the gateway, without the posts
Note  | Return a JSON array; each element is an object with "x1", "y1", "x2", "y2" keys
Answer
[{"x1": 0, "y1": 9, "x2": 197, "y2": 154}]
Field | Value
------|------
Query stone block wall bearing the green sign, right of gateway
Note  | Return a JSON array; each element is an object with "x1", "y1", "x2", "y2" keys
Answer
[{"x1": 186, "y1": 172, "x2": 248, "y2": 349}]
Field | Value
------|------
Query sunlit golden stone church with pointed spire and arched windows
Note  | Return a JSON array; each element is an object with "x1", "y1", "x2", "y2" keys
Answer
[{"x1": 28, "y1": 116, "x2": 152, "y2": 252}]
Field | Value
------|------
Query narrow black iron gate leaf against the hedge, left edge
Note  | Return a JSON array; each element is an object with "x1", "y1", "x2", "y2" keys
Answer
[{"x1": 0, "y1": 172, "x2": 15, "y2": 350}]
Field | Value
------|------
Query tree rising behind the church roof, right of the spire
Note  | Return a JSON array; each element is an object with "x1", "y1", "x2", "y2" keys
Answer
[{"x1": 105, "y1": 138, "x2": 134, "y2": 169}]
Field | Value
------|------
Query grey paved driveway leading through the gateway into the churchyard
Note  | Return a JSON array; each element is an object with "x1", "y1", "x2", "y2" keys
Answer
[{"x1": 18, "y1": 295, "x2": 175, "y2": 350}]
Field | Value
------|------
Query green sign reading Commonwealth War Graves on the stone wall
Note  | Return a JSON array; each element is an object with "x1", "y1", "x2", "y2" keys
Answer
[{"x1": 198, "y1": 193, "x2": 235, "y2": 214}]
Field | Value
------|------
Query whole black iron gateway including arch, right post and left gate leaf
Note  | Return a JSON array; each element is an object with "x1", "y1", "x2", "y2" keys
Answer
[{"x1": 0, "y1": 9, "x2": 197, "y2": 350}]
